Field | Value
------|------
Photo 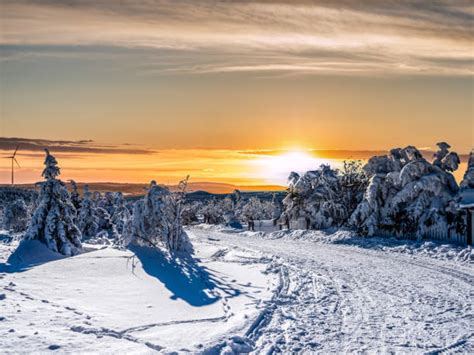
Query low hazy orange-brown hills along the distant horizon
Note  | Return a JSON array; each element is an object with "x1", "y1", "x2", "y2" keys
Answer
[{"x1": 0, "y1": 182, "x2": 285, "y2": 196}]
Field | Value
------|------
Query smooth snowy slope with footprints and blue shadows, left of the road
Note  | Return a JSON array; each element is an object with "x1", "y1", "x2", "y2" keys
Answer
[{"x1": 0, "y1": 236, "x2": 275, "y2": 353}]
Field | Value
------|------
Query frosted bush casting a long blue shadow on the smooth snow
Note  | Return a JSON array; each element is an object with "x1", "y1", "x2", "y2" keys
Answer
[{"x1": 123, "y1": 179, "x2": 192, "y2": 252}]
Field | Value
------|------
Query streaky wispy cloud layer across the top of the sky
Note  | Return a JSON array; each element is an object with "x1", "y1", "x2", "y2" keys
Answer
[{"x1": 1, "y1": 0, "x2": 474, "y2": 76}]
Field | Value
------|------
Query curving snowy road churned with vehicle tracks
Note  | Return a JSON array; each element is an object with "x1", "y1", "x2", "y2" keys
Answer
[{"x1": 192, "y1": 229, "x2": 474, "y2": 354}]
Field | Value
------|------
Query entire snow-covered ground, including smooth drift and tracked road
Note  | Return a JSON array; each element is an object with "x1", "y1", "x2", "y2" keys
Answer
[{"x1": 0, "y1": 226, "x2": 474, "y2": 354}]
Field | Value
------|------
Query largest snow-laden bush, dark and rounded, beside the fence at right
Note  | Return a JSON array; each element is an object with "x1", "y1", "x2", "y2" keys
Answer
[{"x1": 351, "y1": 142, "x2": 459, "y2": 238}]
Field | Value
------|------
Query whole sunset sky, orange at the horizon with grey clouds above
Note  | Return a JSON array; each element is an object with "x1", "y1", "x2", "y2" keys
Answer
[{"x1": 0, "y1": 0, "x2": 474, "y2": 184}]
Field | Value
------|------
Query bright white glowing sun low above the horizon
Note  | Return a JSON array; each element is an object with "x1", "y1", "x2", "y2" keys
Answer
[{"x1": 254, "y1": 149, "x2": 330, "y2": 185}]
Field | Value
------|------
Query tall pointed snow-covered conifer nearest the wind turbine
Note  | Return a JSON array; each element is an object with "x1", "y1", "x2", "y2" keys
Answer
[{"x1": 25, "y1": 149, "x2": 82, "y2": 255}]
